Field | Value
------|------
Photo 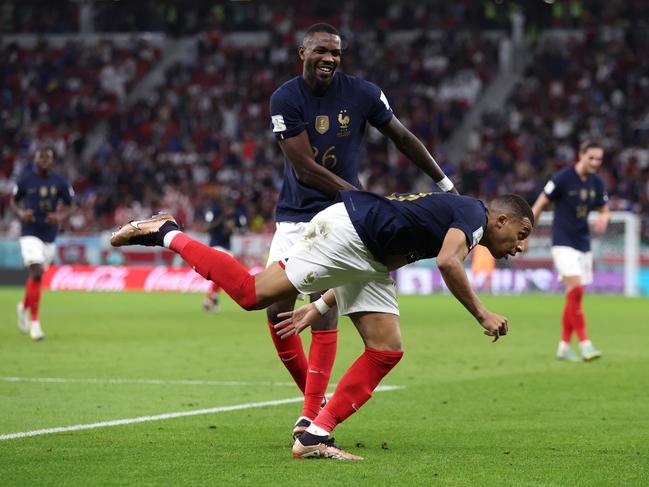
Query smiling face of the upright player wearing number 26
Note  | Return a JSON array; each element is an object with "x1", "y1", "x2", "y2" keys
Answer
[{"x1": 299, "y1": 32, "x2": 341, "y2": 93}]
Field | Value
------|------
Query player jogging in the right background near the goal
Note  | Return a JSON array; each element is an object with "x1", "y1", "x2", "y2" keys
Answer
[{"x1": 532, "y1": 141, "x2": 609, "y2": 361}]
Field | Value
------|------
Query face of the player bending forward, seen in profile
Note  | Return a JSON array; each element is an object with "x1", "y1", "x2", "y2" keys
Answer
[{"x1": 484, "y1": 213, "x2": 532, "y2": 259}]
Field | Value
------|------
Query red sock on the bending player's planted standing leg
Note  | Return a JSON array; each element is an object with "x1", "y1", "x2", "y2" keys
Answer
[{"x1": 313, "y1": 348, "x2": 403, "y2": 432}]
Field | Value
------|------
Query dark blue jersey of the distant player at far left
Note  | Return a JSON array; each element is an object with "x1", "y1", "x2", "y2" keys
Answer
[{"x1": 14, "y1": 167, "x2": 74, "y2": 242}]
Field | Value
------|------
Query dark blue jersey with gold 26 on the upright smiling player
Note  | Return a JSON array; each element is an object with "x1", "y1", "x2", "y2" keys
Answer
[{"x1": 270, "y1": 73, "x2": 393, "y2": 222}]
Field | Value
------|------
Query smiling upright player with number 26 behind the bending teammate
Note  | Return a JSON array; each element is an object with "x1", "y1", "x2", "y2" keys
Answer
[{"x1": 267, "y1": 23, "x2": 457, "y2": 436}]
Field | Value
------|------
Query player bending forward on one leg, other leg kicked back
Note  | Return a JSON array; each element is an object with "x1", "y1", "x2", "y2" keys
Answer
[{"x1": 111, "y1": 191, "x2": 534, "y2": 460}]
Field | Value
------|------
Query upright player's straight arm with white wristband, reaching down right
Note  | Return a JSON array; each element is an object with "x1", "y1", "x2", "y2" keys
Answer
[{"x1": 378, "y1": 117, "x2": 457, "y2": 194}]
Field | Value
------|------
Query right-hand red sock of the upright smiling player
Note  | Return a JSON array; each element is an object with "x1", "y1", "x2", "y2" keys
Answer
[{"x1": 302, "y1": 330, "x2": 338, "y2": 419}]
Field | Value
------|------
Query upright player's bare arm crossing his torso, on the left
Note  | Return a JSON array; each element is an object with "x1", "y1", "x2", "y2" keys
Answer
[{"x1": 279, "y1": 132, "x2": 357, "y2": 198}]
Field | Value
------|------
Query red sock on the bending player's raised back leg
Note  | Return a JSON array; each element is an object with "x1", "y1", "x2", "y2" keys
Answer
[{"x1": 169, "y1": 233, "x2": 257, "y2": 310}]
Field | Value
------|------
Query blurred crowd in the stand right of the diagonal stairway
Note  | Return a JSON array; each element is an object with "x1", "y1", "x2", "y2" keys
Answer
[{"x1": 459, "y1": 24, "x2": 649, "y2": 240}]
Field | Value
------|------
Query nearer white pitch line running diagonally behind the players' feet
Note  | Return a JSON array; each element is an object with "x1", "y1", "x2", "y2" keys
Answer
[{"x1": 0, "y1": 386, "x2": 402, "y2": 441}]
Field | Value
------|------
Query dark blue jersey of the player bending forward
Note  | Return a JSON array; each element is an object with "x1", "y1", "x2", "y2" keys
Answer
[{"x1": 339, "y1": 191, "x2": 487, "y2": 263}]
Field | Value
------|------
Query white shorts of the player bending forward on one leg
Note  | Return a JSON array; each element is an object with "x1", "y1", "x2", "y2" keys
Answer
[{"x1": 282, "y1": 203, "x2": 399, "y2": 316}]
